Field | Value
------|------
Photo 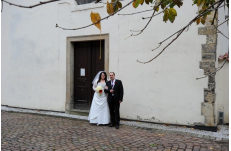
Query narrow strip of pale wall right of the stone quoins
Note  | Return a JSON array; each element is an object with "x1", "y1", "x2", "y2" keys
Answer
[{"x1": 215, "y1": 7, "x2": 229, "y2": 123}]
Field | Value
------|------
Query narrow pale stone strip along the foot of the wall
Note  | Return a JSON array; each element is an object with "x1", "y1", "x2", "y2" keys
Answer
[{"x1": 1, "y1": 106, "x2": 229, "y2": 140}]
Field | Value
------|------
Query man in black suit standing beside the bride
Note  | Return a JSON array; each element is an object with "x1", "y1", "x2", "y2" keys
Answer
[{"x1": 104, "y1": 72, "x2": 124, "y2": 129}]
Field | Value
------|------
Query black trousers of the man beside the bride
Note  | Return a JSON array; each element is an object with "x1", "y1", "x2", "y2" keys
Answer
[{"x1": 109, "y1": 96, "x2": 120, "y2": 125}]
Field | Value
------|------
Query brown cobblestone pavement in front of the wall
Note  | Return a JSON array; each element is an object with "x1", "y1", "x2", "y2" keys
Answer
[{"x1": 1, "y1": 111, "x2": 229, "y2": 151}]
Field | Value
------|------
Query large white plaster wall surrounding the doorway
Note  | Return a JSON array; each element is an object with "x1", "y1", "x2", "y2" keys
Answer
[{"x1": 1, "y1": 0, "x2": 207, "y2": 124}]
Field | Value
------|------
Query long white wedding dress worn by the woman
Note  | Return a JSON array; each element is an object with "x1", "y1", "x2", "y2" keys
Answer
[{"x1": 88, "y1": 81, "x2": 110, "y2": 124}]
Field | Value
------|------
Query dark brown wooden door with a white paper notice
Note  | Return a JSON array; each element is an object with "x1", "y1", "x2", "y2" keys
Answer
[{"x1": 74, "y1": 40, "x2": 104, "y2": 110}]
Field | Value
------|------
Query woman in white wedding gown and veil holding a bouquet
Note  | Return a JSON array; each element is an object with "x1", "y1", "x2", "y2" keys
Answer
[{"x1": 88, "y1": 71, "x2": 110, "y2": 125}]
